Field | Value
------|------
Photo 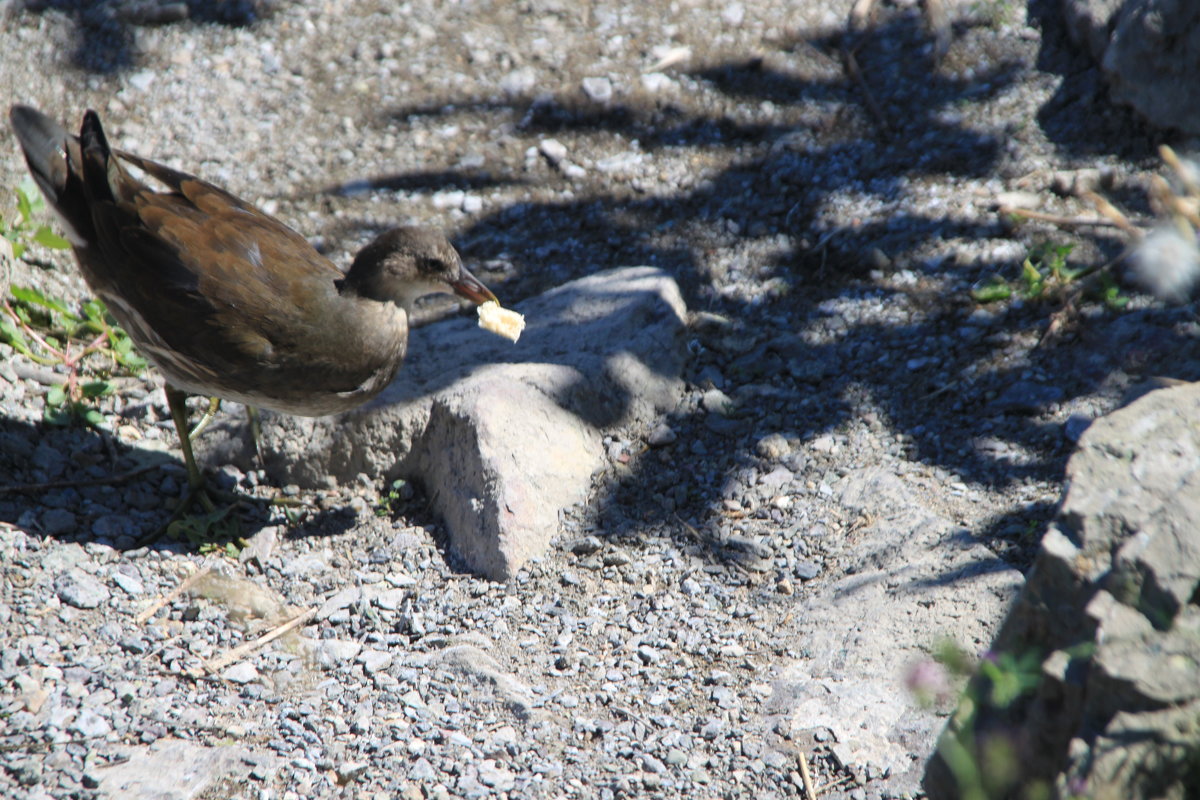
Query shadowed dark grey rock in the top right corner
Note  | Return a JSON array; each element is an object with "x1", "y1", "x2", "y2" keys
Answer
[{"x1": 1062, "y1": 0, "x2": 1200, "y2": 134}]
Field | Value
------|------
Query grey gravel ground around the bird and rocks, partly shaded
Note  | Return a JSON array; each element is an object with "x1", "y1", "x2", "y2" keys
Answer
[{"x1": 0, "y1": 0, "x2": 1200, "y2": 800}]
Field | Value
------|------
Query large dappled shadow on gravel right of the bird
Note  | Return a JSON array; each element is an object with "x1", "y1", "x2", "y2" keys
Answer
[{"x1": 4, "y1": 1, "x2": 1196, "y2": 582}]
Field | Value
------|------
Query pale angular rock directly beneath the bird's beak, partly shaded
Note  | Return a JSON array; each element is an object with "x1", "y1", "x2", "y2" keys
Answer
[{"x1": 209, "y1": 267, "x2": 686, "y2": 579}]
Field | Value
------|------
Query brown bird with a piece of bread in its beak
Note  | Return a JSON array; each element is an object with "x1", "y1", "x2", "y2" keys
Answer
[{"x1": 10, "y1": 106, "x2": 496, "y2": 489}]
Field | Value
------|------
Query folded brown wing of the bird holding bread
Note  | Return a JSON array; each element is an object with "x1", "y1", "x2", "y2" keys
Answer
[{"x1": 92, "y1": 151, "x2": 342, "y2": 372}]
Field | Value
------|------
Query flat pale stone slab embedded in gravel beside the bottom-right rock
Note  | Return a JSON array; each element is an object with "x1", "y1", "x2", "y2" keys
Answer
[{"x1": 767, "y1": 468, "x2": 1022, "y2": 793}]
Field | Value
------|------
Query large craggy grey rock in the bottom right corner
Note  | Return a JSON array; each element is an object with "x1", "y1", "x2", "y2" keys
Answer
[{"x1": 925, "y1": 384, "x2": 1200, "y2": 800}]
